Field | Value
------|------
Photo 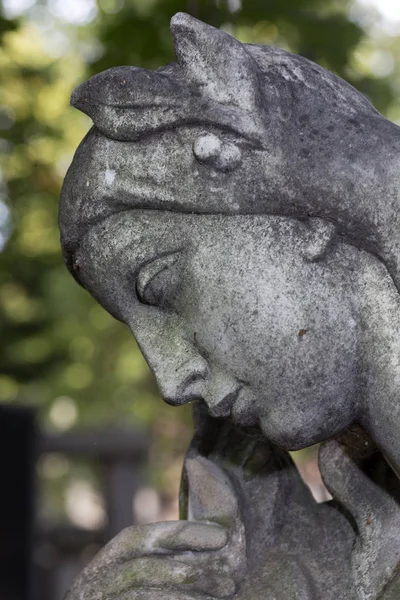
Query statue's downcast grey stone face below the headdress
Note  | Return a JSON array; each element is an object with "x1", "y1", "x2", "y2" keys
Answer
[{"x1": 75, "y1": 210, "x2": 362, "y2": 449}]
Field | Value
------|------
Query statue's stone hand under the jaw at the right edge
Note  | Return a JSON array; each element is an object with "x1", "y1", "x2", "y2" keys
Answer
[{"x1": 320, "y1": 428, "x2": 400, "y2": 600}]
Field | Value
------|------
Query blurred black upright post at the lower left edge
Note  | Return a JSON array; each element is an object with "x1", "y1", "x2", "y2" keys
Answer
[{"x1": 0, "y1": 405, "x2": 36, "y2": 600}]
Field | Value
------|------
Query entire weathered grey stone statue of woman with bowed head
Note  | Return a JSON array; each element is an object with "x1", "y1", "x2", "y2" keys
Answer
[{"x1": 60, "y1": 14, "x2": 400, "y2": 600}]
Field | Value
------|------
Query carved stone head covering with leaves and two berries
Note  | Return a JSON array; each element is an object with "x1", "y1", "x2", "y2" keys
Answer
[{"x1": 60, "y1": 13, "x2": 400, "y2": 288}]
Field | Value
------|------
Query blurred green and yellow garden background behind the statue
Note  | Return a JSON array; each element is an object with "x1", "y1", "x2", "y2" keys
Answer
[{"x1": 0, "y1": 0, "x2": 400, "y2": 600}]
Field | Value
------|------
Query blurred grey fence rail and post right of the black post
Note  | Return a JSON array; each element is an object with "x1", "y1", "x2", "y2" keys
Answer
[{"x1": 34, "y1": 428, "x2": 149, "y2": 600}]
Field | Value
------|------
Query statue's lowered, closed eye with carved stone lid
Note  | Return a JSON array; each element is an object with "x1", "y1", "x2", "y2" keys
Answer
[{"x1": 136, "y1": 250, "x2": 182, "y2": 307}]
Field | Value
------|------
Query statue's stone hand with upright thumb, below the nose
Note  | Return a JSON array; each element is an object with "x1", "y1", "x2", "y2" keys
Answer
[{"x1": 66, "y1": 457, "x2": 245, "y2": 600}]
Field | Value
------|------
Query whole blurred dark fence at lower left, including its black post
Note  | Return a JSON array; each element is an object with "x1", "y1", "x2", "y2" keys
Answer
[{"x1": 0, "y1": 406, "x2": 148, "y2": 600}]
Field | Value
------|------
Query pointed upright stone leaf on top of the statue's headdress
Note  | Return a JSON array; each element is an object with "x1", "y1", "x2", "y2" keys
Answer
[{"x1": 171, "y1": 13, "x2": 259, "y2": 111}]
